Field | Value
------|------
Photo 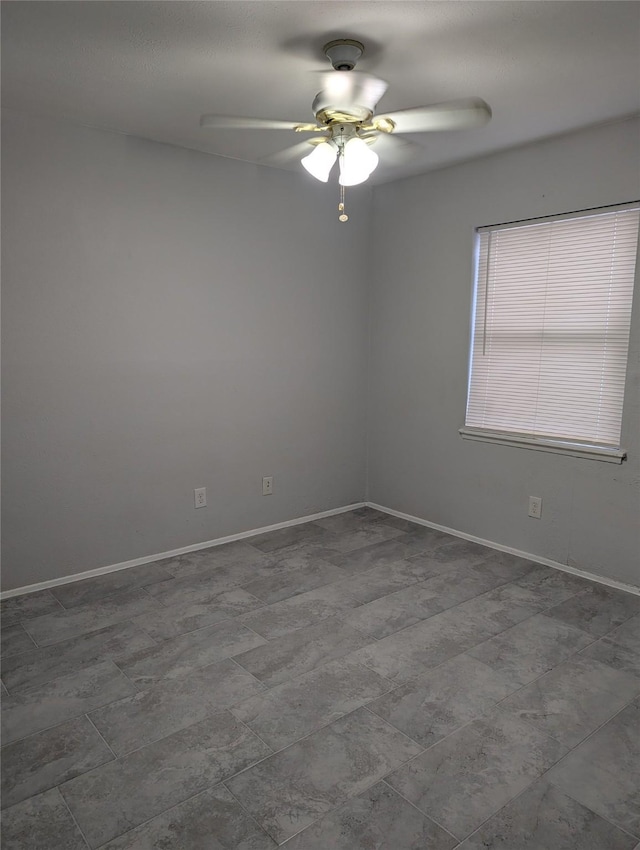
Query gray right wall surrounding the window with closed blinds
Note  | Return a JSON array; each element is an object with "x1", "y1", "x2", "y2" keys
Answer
[{"x1": 368, "y1": 116, "x2": 640, "y2": 585}]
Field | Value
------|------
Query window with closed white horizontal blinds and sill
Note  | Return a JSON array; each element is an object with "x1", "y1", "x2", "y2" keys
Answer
[{"x1": 460, "y1": 204, "x2": 640, "y2": 463}]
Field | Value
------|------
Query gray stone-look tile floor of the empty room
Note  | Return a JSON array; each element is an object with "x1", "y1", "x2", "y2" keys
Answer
[{"x1": 1, "y1": 509, "x2": 640, "y2": 850}]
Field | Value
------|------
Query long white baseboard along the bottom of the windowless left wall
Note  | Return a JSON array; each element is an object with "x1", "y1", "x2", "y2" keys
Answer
[{"x1": 0, "y1": 502, "x2": 365, "y2": 600}]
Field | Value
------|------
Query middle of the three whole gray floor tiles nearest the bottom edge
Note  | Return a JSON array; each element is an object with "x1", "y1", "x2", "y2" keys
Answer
[{"x1": 226, "y1": 708, "x2": 420, "y2": 843}]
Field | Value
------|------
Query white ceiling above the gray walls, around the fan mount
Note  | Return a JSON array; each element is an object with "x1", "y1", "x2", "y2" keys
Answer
[{"x1": 2, "y1": 0, "x2": 640, "y2": 182}]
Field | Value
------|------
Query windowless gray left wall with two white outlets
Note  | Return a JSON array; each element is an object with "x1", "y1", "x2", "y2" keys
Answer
[{"x1": 2, "y1": 112, "x2": 370, "y2": 589}]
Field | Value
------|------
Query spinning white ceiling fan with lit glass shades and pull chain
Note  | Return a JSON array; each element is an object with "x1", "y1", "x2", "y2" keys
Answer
[{"x1": 200, "y1": 38, "x2": 491, "y2": 221}]
